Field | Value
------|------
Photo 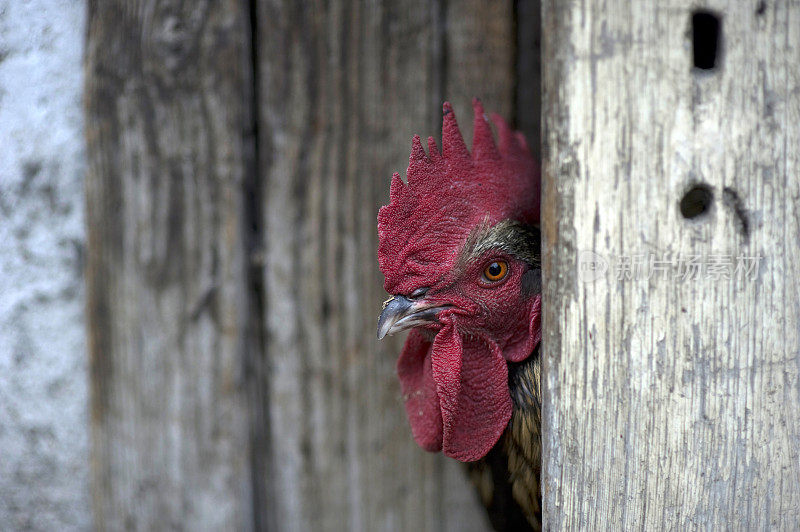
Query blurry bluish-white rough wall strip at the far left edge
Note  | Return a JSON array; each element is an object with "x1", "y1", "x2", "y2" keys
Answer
[{"x1": 0, "y1": 0, "x2": 91, "y2": 530}]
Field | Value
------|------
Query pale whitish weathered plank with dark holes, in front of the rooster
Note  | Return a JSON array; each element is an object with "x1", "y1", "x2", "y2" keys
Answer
[{"x1": 543, "y1": 0, "x2": 800, "y2": 530}]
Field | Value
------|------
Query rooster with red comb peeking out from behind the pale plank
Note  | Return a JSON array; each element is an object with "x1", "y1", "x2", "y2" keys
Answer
[{"x1": 378, "y1": 100, "x2": 541, "y2": 530}]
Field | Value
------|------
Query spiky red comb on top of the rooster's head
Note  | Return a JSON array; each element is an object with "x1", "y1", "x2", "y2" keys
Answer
[{"x1": 378, "y1": 99, "x2": 540, "y2": 294}]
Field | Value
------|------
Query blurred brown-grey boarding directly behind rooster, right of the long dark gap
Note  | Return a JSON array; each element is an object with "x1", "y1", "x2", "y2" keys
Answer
[{"x1": 256, "y1": 1, "x2": 514, "y2": 530}]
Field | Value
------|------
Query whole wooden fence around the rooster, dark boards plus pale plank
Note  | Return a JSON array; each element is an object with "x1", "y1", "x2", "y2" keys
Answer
[{"x1": 86, "y1": 0, "x2": 800, "y2": 530}]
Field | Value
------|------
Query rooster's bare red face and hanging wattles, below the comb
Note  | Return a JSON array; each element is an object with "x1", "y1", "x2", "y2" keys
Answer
[{"x1": 398, "y1": 251, "x2": 540, "y2": 462}]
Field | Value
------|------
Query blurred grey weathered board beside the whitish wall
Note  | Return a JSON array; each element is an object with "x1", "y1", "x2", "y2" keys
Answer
[{"x1": 86, "y1": 0, "x2": 254, "y2": 530}]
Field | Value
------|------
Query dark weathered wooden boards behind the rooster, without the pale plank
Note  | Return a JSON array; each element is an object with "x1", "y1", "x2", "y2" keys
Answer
[{"x1": 86, "y1": 0, "x2": 539, "y2": 530}]
